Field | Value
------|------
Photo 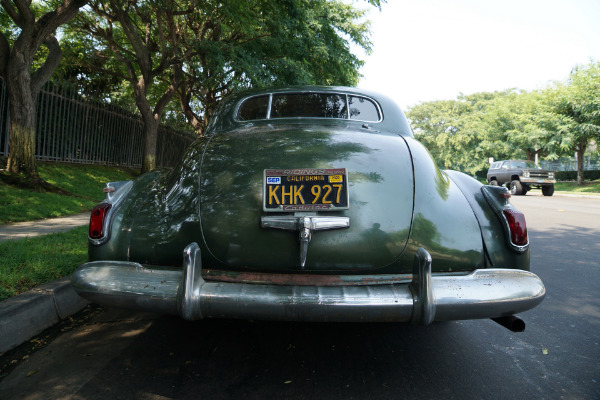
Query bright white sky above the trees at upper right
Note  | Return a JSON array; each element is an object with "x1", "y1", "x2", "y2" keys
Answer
[{"x1": 355, "y1": 0, "x2": 600, "y2": 109}]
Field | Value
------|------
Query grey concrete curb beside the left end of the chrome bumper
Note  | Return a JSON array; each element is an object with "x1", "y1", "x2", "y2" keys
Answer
[{"x1": 0, "y1": 277, "x2": 89, "y2": 353}]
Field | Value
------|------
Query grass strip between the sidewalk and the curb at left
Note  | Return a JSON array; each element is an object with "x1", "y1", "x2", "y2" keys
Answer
[{"x1": 0, "y1": 226, "x2": 88, "y2": 301}]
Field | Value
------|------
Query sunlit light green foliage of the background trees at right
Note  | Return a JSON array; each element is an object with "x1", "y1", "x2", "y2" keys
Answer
[{"x1": 407, "y1": 63, "x2": 600, "y2": 175}]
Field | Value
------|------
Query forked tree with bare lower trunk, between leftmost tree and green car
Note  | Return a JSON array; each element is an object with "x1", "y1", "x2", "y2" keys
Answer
[{"x1": 78, "y1": 0, "x2": 189, "y2": 172}]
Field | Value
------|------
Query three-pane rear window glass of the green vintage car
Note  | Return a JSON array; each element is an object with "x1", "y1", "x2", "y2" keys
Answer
[{"x1": 237, "y1": 93, "x2": 381, "y2": 122}]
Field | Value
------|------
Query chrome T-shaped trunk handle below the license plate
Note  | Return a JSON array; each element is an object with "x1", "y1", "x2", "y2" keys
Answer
[{"x1": 260, "y1": 215, "x2": 350, "y2": 269}]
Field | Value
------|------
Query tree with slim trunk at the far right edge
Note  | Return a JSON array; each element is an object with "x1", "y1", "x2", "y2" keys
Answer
[{"x1": 551, "y1": 62, "x2": 600, "y2": 185}]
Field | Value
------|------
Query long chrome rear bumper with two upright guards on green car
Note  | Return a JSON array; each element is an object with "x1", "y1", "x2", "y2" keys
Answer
[{"x1": 72, "y1": 243, "x2": 546, "y2": 325}]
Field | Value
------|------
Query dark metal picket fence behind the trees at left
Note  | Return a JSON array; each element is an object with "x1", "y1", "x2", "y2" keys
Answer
[{"x1": 0, "y1": 79, "x2": 195, "y2": 167}]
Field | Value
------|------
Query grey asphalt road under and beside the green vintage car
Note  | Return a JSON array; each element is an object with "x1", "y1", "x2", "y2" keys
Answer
[{"x1": 0, "y1": 192, "x2": 600, "y2": 400}]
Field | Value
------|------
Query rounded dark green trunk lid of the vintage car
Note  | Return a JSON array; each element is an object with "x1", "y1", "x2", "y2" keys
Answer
[{"x1": 200, "y1": 121, "x2": 414, "y2": 273}]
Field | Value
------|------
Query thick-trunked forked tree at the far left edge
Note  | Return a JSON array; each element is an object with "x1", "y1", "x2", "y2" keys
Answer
[{"x1": 0, "y1": 0, "x2": 87, "y2": 181}]
